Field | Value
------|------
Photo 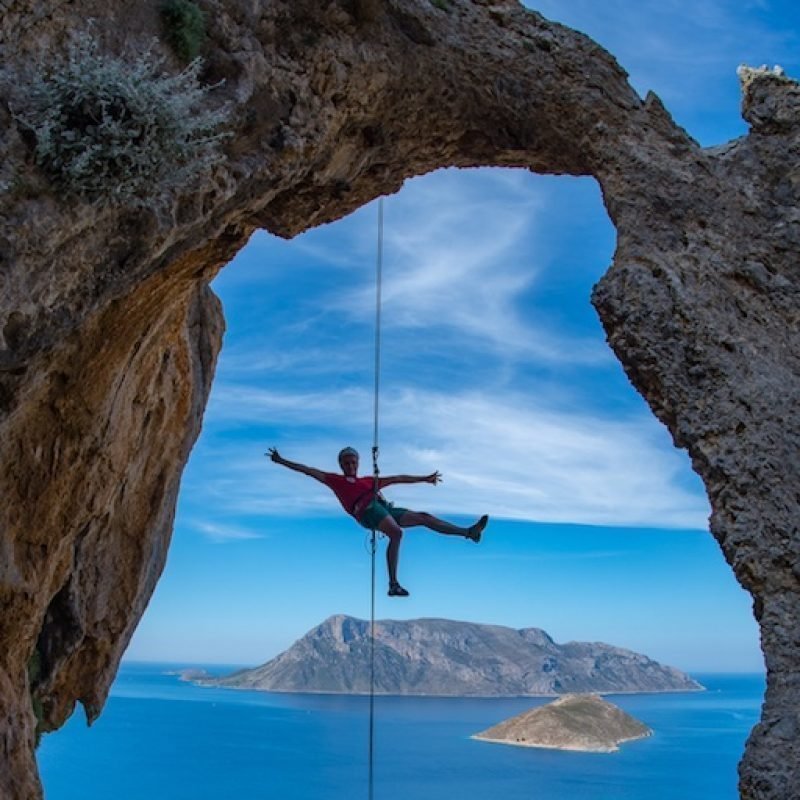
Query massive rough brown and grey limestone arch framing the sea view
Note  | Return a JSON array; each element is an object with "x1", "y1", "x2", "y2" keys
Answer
[{"x1": 0, "y1": 0, "x2": 800, "y2": 800}]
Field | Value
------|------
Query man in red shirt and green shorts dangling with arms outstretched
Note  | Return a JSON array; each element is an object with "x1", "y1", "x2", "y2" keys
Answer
[{"x1": 266, "y1": 447, "x2": 489, "y2": 597}]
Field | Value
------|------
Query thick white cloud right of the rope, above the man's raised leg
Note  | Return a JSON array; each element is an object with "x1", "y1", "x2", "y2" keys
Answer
[{"x1": 378, "y1": 392, "x2": 707, "y2": 527}]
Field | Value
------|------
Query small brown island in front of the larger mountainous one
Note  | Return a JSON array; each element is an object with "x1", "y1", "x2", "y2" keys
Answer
[{"x1": 472, "y1": 694, "x2": 653, "y2": 753}]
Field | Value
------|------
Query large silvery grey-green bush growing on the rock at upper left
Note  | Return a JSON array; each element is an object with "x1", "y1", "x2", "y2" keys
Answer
[{"x1": 17, "y1": 34, "x2": 227, "y2": 206}]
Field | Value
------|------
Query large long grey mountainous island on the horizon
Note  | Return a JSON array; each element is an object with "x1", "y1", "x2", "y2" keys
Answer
[{"x1": 196, "y1": 614, "x2": 703, "y2": 697}]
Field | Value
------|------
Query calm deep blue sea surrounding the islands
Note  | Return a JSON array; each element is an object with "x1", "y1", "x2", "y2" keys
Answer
[{"x1": 39, "y1": 664, "x2": 764, "y2": 800}]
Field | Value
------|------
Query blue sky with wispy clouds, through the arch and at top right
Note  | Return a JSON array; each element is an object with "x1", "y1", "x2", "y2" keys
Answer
[{"x1": 127, "y1": 0, "x2": 800, "y2": 671}]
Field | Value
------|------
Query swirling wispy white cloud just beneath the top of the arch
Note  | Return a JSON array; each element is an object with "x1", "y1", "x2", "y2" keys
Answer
[{"x1": 329, "y1": 170, "x2": 609, "y2": 364}]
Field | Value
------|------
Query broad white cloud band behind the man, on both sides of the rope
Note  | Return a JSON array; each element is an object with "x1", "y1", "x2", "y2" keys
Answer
[{"x1": 186, "y1": 387, "x2": 708, "y2": 529}]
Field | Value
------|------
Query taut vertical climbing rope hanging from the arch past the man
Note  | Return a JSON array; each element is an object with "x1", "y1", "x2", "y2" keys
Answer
[{"x1": 367, "y1": 197, "x2": 383, "y2": 800}]
